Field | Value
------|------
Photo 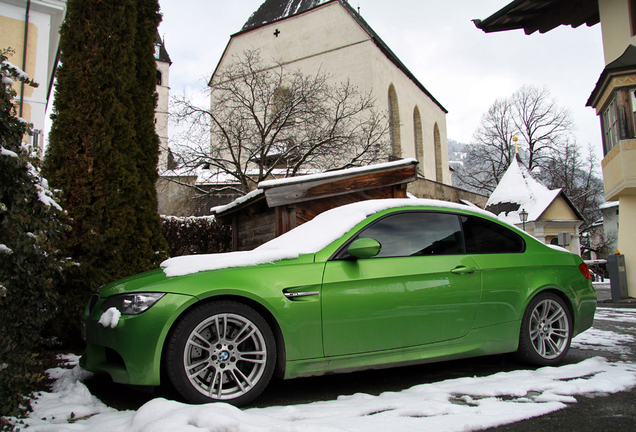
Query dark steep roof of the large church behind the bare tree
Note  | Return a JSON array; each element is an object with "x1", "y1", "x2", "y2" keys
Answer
[{"x1": 224, "y1": 0, "x2": 448, "y2": 113}]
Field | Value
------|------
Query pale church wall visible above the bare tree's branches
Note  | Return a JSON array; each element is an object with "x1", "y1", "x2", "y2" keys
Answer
[{"x1": 219, "y1": 3, "x2": 451, "y2": 184}]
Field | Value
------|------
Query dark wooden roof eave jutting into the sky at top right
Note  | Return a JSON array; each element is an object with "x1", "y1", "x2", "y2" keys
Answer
[{"x1": 473, "y1": 0, "x2": 601, "y2": 35}]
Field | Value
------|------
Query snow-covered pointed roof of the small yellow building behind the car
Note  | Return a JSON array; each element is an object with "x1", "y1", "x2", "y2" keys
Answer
[{"x1": 486, "y1": 158, "x2": 583, "y2": 225}]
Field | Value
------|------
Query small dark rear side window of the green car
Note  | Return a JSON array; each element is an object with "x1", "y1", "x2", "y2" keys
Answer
[{"x1": 461, "y1": 216, "x2": 526, "y2": 254}]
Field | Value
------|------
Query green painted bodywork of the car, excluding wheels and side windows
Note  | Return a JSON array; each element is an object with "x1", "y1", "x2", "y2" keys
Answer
[{"x1": 81, "y1": 201, "x2": 596, "y2": 403}]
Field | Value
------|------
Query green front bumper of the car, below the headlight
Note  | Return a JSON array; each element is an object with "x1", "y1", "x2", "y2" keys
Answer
[{"x1": 80, "y1": 293, "x2": 197, "y2": 386}]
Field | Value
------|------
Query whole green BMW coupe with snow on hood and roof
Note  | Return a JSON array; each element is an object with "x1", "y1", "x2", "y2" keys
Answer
[{"x1": 80, "y1": 199, "x2": 596, "y2": 405}]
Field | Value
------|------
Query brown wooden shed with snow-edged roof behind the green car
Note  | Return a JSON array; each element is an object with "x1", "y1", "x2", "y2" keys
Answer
[{"x1": 213, "y1": 159, "x2": 418, "y2": 251}]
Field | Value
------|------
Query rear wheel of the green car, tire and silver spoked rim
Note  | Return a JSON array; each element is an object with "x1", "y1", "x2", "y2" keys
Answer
[{"x1": 517, "y1": 292, "x2": 572, "y2": 366}]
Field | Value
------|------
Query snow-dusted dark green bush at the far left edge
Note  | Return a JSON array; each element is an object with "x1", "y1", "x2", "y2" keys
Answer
[{"x1": 0, "y1": 51, "x2": 66, "y2": 415}]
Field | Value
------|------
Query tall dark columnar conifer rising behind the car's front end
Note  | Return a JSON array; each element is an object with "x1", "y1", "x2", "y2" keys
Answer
[{"x1": 45, "y1": 0, "x2": 166, "y2": 340}]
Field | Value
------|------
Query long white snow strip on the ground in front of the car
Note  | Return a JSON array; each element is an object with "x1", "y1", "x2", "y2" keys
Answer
[{"x1": 8, "y1": 357, "x2": 636, "y2": 432}]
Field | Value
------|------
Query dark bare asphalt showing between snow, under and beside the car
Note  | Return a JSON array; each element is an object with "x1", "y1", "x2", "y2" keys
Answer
[{"x1": 86, "y1": 288, "x2": 636, "y2": 432}]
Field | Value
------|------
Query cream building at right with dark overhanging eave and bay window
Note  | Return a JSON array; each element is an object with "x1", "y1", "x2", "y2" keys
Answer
[{"x1": 474, "y1": 0, "x2": 636, "y2": 297}]
